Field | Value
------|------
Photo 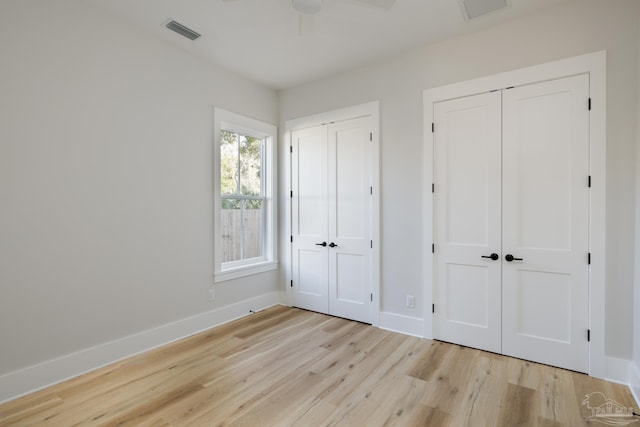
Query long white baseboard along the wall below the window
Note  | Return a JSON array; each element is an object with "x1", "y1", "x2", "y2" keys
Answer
[{"x1": 0, "y1": 292, "x2": 284, "y2": 403}]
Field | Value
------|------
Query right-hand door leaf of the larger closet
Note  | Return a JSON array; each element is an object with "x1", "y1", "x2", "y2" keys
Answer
[{"x1": 502, "y1": 75, "x2": 589, "y2": 372}]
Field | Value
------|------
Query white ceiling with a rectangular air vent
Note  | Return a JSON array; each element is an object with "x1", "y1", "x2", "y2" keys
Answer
[{"x1": 90, "y1": 0, "x2": 573, "y2": 90}]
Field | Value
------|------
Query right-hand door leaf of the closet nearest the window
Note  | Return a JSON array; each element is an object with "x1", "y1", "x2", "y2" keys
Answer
[{"x1": 328, "y1": 117, "x2": 372, "y2": 323}]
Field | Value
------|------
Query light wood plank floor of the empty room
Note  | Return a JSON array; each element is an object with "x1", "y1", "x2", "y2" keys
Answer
[{"x1": 0, "y1": 307, "x2": 637, "y2": 427}]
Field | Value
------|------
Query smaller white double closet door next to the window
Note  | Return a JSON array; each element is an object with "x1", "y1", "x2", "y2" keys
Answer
[{"x1": 291, "y1": 117, "x2": 372, "y2": 323}]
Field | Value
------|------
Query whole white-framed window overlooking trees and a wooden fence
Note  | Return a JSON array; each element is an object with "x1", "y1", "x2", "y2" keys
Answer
[{"x1": 214, "y1": 108, "x2": 277, "y2": 282}]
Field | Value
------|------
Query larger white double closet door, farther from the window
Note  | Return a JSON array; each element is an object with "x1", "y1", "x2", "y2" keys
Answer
[{"x1": 434, "y1": 75, "x2": 589, "y2": 372}]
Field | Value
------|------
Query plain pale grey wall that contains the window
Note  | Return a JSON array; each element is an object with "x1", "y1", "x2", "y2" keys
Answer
[{"x1": 0, "y1": 0, "x2": 278, "y2": 388}]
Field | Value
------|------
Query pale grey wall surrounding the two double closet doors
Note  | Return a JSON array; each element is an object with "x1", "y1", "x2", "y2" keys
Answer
[{"x1": 279, "y1": 0, "x2": 638, "y2": 360}]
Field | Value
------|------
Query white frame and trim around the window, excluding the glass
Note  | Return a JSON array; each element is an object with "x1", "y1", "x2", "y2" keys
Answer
[{"x1": 213, "y1": 108, "x2": 278, "y2": 283}]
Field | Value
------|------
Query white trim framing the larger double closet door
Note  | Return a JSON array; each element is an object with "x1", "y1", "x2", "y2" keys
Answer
[{"x1": 423, "y1": 51, "x2": 607, "y2": 378}]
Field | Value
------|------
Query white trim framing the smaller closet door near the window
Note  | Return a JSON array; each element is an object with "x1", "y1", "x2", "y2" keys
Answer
[{"x1": 282, "y1": 101, "x2": 381, "y2": 326}]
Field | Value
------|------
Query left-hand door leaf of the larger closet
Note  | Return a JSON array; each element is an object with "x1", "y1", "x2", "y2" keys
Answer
[{"x1": 433, "y1": 92, "x2": 501, "y2": 353}]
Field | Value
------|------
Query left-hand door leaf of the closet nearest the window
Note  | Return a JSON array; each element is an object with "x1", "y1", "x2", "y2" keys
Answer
[{"x1": 291, "y1": 126, "x2": 329, "y2": 313}]
